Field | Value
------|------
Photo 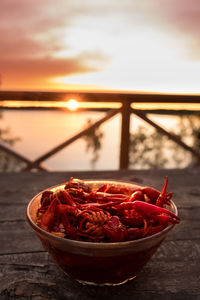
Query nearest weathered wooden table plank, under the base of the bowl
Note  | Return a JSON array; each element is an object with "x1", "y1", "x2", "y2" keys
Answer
[{"x1": 0, "y1": 240, "x2": 200, "y2": 300}]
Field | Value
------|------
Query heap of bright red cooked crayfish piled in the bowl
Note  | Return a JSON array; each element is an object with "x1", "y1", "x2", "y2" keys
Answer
[{"x1": 37, "y1": 177, "x2": 180, "y2": 242}]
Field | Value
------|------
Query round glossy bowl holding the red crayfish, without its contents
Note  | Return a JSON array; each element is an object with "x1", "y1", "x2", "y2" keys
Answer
[{"x1": 26, "y1": 180, "x2": 178, "y2": 285}]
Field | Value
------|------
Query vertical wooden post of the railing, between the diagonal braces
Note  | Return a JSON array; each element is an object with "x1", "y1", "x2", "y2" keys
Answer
[{"x1": 120, "y1": 99, "x2": 131, "y2": 169}]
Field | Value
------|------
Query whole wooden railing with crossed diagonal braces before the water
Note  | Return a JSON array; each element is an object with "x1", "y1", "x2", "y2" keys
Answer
[{"x1": 0, "y1": 91, "x2": 200, "y2": 171}]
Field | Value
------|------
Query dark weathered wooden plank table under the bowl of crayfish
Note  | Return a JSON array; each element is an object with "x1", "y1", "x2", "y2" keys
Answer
[{"x1": 0, "y1": 169, "x2": 200, "y2": 300}]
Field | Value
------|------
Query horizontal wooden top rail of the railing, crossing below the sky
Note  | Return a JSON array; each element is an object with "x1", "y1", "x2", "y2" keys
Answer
[{"x1": 0, "y1": 91, "x2": 200, "y2": 103}]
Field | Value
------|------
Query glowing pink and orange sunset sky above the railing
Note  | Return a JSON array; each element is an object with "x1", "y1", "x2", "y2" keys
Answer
[{"x1": 0, "y1": 0, "x2": 200, "y2": 93}]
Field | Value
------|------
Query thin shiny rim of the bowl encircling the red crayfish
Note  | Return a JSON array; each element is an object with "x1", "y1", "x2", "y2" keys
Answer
[{"x1": 26, "y1": 179, "x2": 178, "y2": 249}]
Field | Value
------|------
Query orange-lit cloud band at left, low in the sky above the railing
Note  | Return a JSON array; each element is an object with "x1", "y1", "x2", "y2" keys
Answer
[{"x1": 0, "y1": 55, "x2": 108, "y2": 89}]
